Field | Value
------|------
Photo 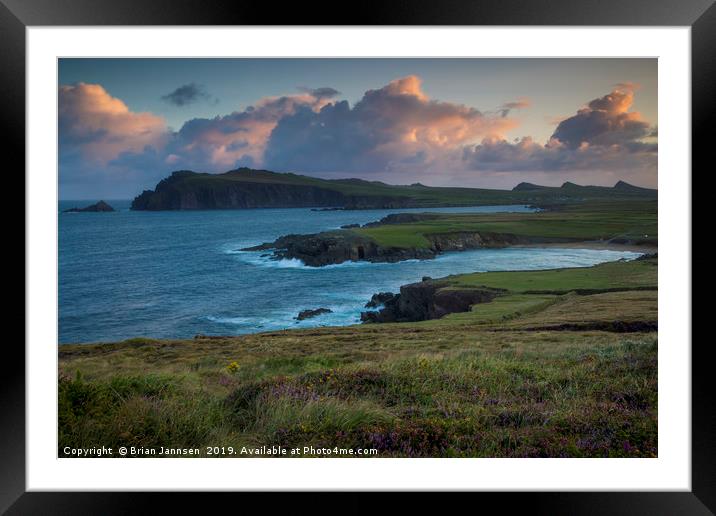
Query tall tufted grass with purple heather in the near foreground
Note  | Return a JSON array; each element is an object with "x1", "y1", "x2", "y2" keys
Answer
[{"x1": 59, "y1": 335, "x2": 657, "y2": 457}]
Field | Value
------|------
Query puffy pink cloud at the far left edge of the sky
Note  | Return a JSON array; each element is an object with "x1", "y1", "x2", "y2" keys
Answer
[{"x1": 58, "y1": 83, "x2": 167, "y2": 164}]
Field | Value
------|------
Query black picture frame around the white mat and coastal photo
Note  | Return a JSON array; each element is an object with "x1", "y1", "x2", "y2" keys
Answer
[{"x1": 0, "y1": 0, "x2": 716, "y2": 515}]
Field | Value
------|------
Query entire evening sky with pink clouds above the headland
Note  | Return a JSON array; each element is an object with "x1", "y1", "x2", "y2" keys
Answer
[{"x1": 58, "y1": 58, "x2": 658, "y2": 199}]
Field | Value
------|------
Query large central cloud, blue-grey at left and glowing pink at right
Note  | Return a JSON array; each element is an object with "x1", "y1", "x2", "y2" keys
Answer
[{"x1": 264, "y1": 76, "x2": 515, "y2": 172}]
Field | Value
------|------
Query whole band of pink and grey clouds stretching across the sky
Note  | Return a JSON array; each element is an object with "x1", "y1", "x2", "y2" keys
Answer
[{"x1": 59, "y1": 76, "x2": 657, "y2": 198}]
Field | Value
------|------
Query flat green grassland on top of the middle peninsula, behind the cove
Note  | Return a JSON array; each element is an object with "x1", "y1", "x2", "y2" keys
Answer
[{"x1": 351, "y1": 200, "x2": 658, "y2": 248}]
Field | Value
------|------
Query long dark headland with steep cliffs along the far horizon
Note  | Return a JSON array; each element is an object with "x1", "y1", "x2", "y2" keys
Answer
[{"x1": 131, "y1": 168, "x2": 656, "y2": 211}]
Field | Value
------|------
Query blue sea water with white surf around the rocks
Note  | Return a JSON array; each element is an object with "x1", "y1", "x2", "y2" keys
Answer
[{"x1": 58, "y1": 201, "x2": 639, "y2": 343}]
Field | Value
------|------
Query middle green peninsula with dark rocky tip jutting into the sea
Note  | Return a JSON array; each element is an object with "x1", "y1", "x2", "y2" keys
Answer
[{"x1": 243, "y1": 198, "x2": 657, "y2": 267}]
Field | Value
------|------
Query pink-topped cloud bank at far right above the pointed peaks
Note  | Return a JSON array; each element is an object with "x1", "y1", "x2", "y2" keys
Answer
[{"x1": 463, "y1": 85, "x2": 657, "y2": 172}]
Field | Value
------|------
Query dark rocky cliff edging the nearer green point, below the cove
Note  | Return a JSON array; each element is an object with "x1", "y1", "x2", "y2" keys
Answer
[{"x1": 361, "y1": 281, "x2": 504, "y2": 323}]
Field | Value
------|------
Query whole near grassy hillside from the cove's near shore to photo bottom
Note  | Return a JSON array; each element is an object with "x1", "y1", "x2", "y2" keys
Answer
[{"x1": 59, "y1": 258, "x2": 658, "y2": 457}]
